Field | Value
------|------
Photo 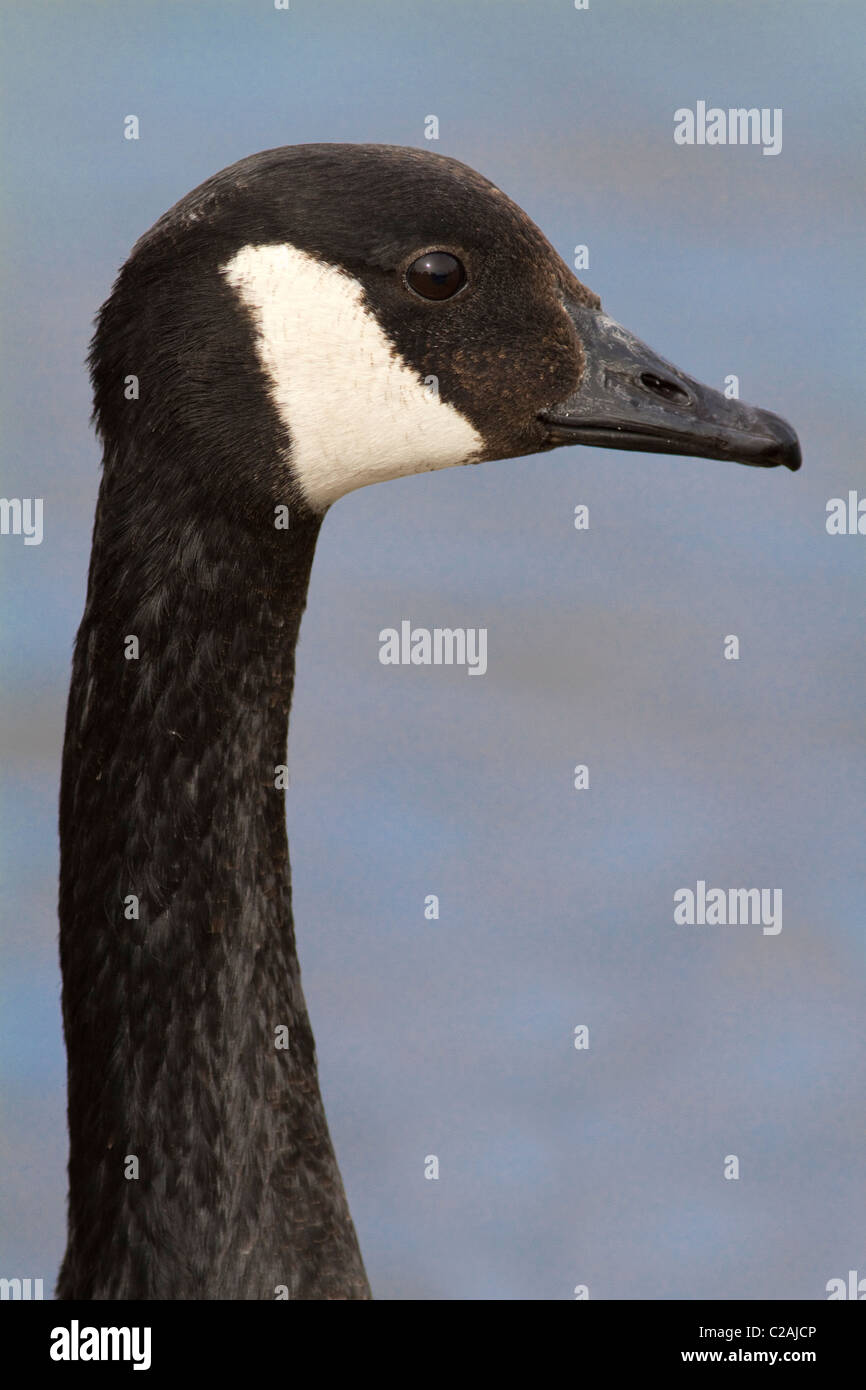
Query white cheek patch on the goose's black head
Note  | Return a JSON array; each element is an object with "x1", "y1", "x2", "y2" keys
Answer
[{"x1": 222, "y1": 245, "x2": 482, "y2": 512}]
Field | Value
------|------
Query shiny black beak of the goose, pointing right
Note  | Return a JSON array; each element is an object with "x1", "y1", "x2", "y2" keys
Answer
[{"x1": 539, "y1": 304, "x2": 802, "y2": 470}]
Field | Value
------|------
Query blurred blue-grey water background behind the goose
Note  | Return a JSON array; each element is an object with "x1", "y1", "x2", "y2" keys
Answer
[{"x1": 0, "y1": 0, "x2": 866, "y2": 1300}]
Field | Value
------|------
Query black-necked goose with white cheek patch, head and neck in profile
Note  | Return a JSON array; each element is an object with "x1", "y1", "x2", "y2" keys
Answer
[{"x1": 57, "y1": 145, "x2": 801, "y2": 1300}]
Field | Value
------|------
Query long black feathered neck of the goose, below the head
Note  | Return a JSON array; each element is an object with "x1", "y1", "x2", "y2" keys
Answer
[{"x1": 57, "y1": 450, "x2": 370, "y2": 1300}]
